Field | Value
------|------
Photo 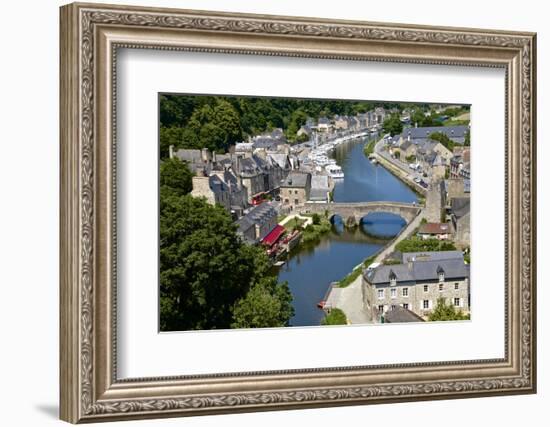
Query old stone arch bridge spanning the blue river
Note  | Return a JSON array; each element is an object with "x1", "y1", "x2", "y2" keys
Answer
[{"x1": 301, "y1": 202, "x2": 422, "y2": 224}]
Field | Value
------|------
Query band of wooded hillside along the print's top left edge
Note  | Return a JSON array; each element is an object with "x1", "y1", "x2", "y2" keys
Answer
[{"x1": 160, "y1": 94, "x2": 434, "y2": 158}]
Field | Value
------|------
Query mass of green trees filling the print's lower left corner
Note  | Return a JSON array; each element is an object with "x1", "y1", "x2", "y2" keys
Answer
[{"x1": 160, "y1": 159, "x2": 293, "y2": 331}]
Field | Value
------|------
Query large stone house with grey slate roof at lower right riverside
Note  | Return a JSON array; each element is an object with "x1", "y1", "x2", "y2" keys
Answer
[{"x1": 362, "y1": 251, "x2": 470, "y2": 322}]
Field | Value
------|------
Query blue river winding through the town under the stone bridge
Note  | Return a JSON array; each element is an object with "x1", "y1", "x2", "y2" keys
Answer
[{"x1": 278, "y1": 139, "x2": 417, "y2": 326}]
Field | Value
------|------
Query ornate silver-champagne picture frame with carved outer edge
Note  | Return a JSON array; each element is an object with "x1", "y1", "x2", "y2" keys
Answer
[{"x1": 60, "y1": 3, "x2": 536, "y2": 423}]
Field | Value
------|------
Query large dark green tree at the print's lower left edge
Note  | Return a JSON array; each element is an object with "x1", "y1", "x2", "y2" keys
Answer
[{"x1": 160, "y1": 196, "x2": 274, "y2": 331}]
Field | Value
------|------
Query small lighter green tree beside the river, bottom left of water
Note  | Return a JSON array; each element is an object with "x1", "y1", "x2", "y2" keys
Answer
[{"x1": 231, "y1": 277, "x2": 294, "y2": 328}]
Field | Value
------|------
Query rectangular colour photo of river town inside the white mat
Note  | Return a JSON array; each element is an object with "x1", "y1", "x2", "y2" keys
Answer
[{"x1": 159, "y1": 94, "x2": 471, "y2": 332}]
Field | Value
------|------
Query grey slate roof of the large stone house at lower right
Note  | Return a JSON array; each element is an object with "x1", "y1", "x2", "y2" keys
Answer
[{"x1": 364, "y1": 254, "x2": 470, "y2": 285}]
